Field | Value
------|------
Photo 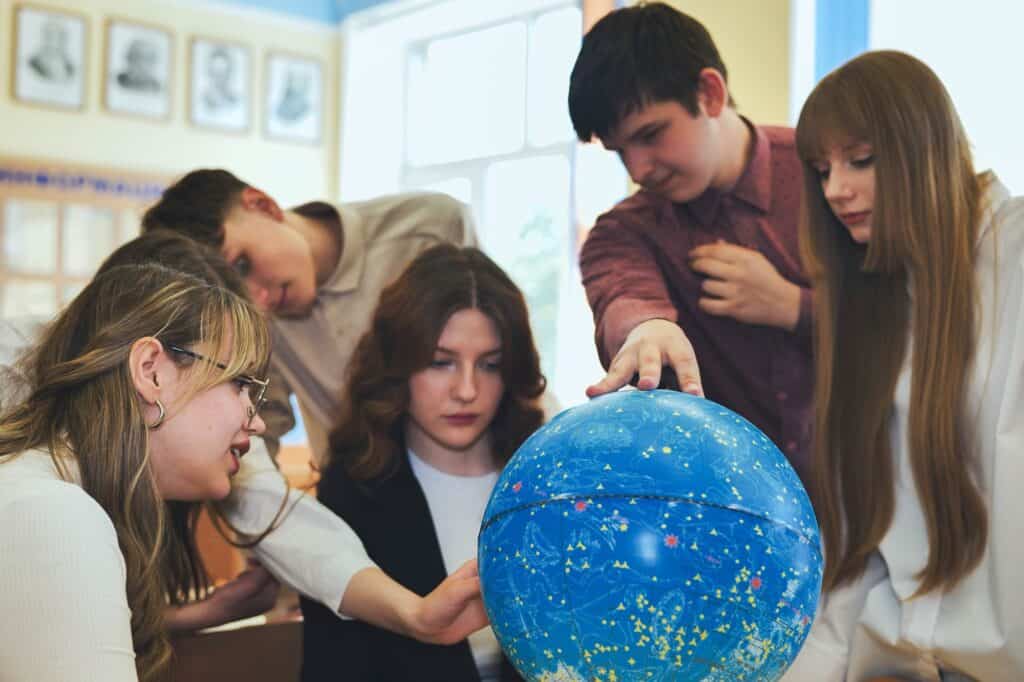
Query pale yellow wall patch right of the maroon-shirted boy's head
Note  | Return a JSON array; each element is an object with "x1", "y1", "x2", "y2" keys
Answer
[{"x1": 667, "y1": 0, "x2": 792, "y2": 125}]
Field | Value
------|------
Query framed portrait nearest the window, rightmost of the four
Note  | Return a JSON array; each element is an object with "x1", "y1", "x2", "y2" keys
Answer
[{"x1": 263, "y1": 52, "x2": 324, "y2": 143}]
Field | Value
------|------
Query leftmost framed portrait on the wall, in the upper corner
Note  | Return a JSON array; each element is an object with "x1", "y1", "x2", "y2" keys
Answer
[{"x1": 13, "y1": 5, "x2": 87, "y2": 110}]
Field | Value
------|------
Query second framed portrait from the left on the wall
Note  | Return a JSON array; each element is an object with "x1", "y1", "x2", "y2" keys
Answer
[{"x1": 103, "y1": 19, "x2": 174, "y2": 119}]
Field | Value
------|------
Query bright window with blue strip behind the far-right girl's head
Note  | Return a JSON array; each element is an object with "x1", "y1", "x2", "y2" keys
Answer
[{"x1": 792, "y1": 0, "x2": 1024, "y2": 194}]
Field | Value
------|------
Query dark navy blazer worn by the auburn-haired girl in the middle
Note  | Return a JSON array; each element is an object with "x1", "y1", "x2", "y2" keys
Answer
[{"x1": 301, "y1": 446, "x2": 522, "y2": 682}]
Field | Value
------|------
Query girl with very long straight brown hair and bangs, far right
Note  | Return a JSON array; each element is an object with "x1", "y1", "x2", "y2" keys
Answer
[{"x1": 784, "y1": 51, "x2": 1024, "y2": 682}]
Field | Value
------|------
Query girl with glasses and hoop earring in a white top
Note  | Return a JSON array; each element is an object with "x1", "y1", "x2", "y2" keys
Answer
[{"x1": 0, "y1": 265, "x2": 270, "y2": 682}]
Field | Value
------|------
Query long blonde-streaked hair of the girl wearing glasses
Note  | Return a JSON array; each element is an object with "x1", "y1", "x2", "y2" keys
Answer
[{"x1": 0, "y1": 264, "x2": 270, "y2": 680}]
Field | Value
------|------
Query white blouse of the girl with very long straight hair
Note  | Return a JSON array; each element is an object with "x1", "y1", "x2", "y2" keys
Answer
[{"x1": 783, "y1": 177, "x2": 1024, "y2": 682}]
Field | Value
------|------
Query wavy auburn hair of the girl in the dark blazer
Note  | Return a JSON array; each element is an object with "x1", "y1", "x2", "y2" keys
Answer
[{"x1": 326, "y1": 244, "x2": 545, "y2": 480}]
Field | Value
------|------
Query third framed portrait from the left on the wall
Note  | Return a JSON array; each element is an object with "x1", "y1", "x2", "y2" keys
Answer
[{"x1": 188, "y1": 38, "x2": 252, "y2": 132}]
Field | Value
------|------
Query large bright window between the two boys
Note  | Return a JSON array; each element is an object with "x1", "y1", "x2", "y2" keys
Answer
[{"x1": 340, "y1": 0, "x2": 628, "y2": 406}]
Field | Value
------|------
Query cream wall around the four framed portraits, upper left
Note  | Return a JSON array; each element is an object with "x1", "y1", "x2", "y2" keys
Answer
[{"x1": 0, "y1": 0, "x2": 339, "y2": 205}]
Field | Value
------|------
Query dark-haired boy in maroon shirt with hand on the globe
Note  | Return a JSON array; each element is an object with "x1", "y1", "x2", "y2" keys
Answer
[{"x1": 569, "y1": 3, "x2": 812, "y2": 476}]
